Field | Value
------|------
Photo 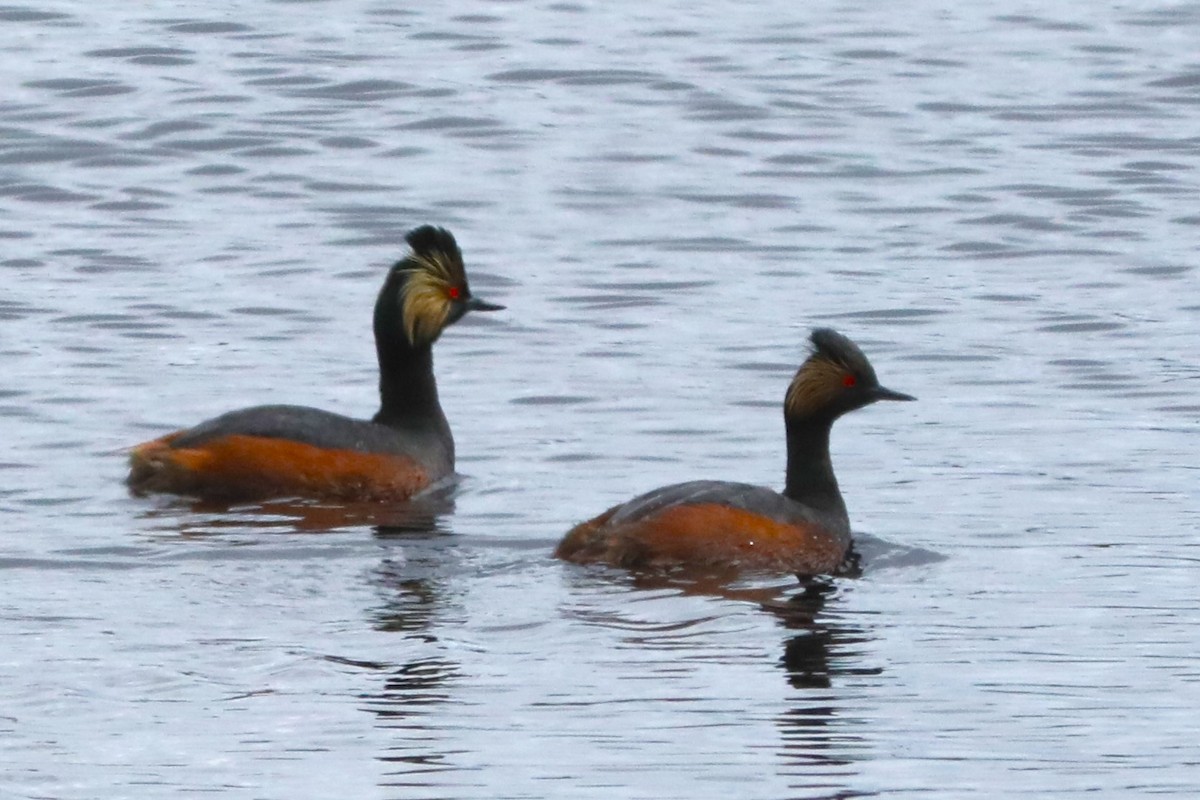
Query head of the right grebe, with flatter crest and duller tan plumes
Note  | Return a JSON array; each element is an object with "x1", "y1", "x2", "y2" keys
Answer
[{"x1": 784, "y1": 327, "x2": 917, "y2": 421}]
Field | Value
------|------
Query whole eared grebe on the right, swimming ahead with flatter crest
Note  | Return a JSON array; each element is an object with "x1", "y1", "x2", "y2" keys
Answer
[{"x1": 554, "y1": 329, "x2": 916, "y2": 577}]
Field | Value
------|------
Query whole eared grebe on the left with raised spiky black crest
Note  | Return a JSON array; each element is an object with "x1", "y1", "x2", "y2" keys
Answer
[{"x1": 127, "y1": 225, "x2": 503, "y2": 501}]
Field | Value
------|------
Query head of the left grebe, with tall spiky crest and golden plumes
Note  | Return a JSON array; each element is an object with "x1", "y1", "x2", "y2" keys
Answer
[{"x1": 376, "y1": 225, "x2": 504, "y2": 347}]
